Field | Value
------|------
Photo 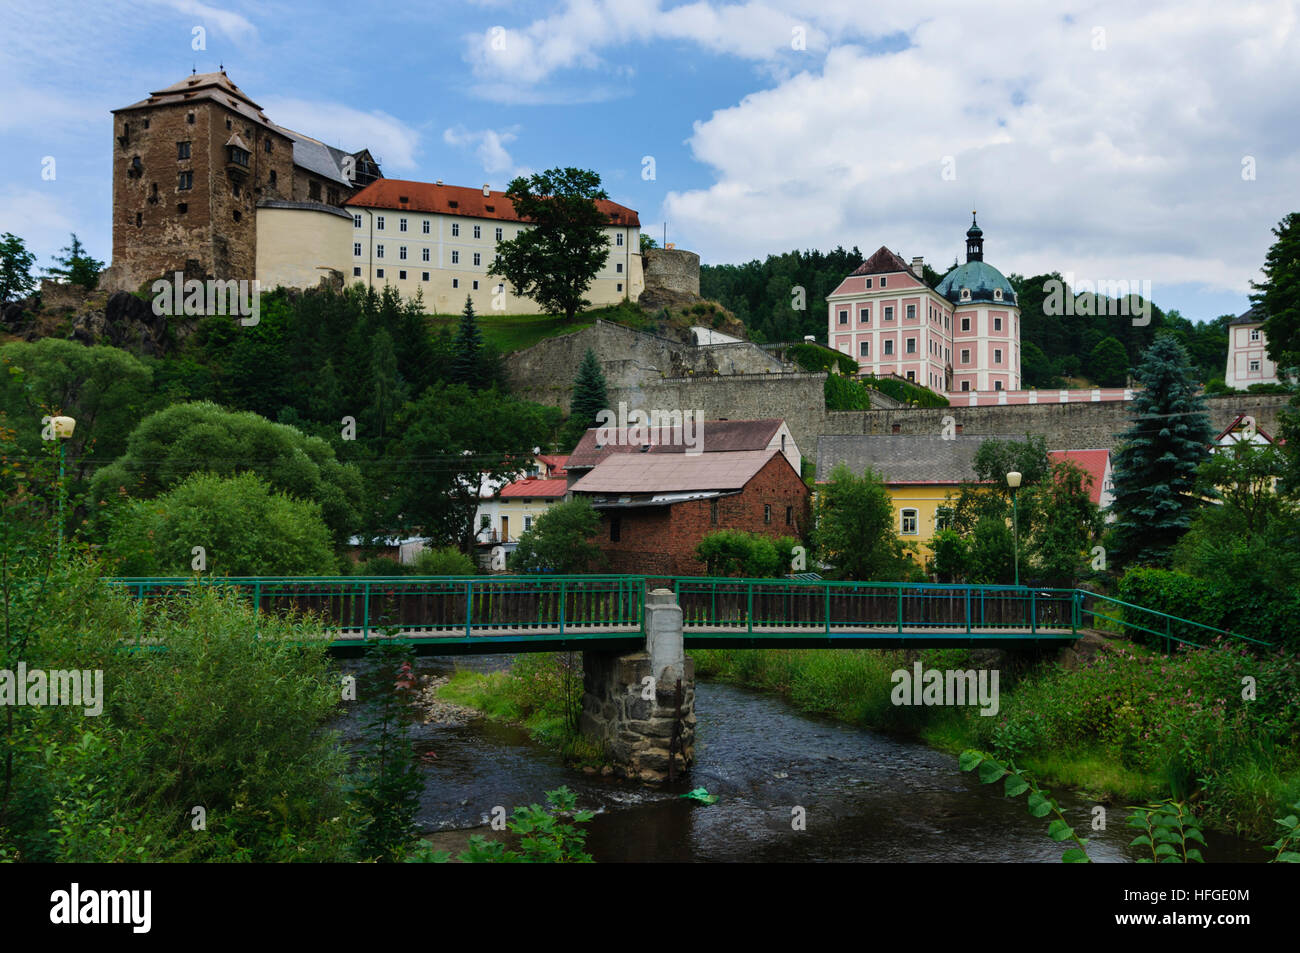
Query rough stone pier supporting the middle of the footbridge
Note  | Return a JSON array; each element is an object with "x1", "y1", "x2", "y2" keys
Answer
[{"x1": 580, "y1": 589, "x2": 696, "y2": 784}]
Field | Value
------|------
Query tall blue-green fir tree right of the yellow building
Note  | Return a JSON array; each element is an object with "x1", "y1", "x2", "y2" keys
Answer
[{"x1": 1110, "y1": 334, "x2": 1214, "y2": 564}]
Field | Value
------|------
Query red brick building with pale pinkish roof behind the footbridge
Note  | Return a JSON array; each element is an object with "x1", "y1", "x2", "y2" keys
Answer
[{"x1": 571, "y1": 449, "x2": 810, "y2": 576}]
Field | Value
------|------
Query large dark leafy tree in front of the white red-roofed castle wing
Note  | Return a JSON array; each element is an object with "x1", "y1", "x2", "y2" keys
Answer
[{"x1": 489, "y1": 168, "x2": 610, "y2": 320}]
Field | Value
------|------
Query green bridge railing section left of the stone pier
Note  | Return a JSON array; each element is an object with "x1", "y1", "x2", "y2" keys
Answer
[{"x1": 105, "y1": 575, "x2": 646, "y2": 640}]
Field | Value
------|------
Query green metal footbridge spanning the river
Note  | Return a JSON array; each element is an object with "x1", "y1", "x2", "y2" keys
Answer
[{"x1": 107, "y1": 575, "x2": 1266, "y2": 655}]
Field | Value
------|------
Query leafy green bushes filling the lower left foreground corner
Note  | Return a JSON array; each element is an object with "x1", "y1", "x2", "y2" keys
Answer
[{"x1": 0, "y1": 566, "x2": 360, "y2": 862}]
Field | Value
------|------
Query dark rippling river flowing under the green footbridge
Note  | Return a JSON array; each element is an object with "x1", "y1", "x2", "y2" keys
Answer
[{"x1": 335, "y1": 657, "x2": 1266, "y2": 863}]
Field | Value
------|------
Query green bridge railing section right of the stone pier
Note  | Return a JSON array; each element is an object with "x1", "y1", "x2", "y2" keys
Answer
[{"x1": 672, "y1": 576, "x2": 1080, "y2": 634}]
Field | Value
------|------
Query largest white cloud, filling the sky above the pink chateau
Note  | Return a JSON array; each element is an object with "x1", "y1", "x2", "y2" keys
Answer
[{"x1": 663, "y1": 0, "x2": 1300, "y2": 291}]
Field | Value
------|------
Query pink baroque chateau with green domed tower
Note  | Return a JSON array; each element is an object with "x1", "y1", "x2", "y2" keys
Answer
[{"x1": 827, "y1": 212, "x2": 1021, "y2": 394}]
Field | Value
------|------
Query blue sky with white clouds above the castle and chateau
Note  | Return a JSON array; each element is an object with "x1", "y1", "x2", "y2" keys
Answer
[{"x1": 0, "y1": 0, "x2": 1300, "y2": 321}]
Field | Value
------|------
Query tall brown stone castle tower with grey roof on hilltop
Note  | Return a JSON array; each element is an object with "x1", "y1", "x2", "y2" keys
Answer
[{"x1": 101, "y1": 70, "x2": 381, "y2": 290}]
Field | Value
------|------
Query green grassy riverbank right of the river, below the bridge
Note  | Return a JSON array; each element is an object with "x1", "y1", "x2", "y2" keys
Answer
[{"x1": 690, "y1": 644, "x2": 1300, "y2": 839}]
